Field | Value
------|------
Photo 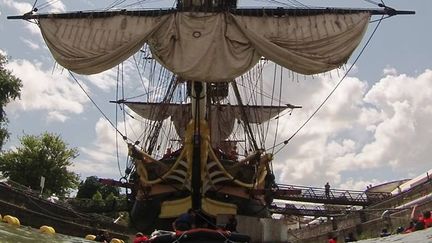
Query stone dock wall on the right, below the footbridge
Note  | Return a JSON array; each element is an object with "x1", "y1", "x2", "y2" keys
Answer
[{"x1": 217, "y1": 181, "x2": 432, "y2": 243}]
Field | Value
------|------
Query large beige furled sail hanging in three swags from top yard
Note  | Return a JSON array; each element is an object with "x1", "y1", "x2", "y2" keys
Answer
[{"x1": 39, "y1": 11, "x2": 370, "y2": 82}]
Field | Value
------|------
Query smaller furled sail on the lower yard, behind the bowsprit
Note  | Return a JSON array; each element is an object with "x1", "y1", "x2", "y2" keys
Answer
[{"x1": 125, "y1": 102, "x2": 289, "y2": 145}]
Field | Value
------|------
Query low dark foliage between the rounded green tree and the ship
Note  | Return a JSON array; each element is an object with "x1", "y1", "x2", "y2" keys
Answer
[{"x1": 76, "y1": 176, "x2": 120, "y2": 199}]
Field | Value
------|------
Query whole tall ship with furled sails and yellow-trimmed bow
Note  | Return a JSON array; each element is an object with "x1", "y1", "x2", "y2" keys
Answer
[{"x1": 8, "y1": 0, "x2": 413, "y2": 234}]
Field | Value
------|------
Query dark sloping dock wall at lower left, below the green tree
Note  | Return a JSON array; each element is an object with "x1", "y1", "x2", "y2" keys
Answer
[{"x1": 0, "y1": 182, "x2": 134, "y2": 240}]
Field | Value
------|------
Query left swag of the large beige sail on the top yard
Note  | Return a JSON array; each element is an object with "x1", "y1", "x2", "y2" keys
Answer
[{"x1": 39, "y1": 15, "x2": 169, "y2": 74}]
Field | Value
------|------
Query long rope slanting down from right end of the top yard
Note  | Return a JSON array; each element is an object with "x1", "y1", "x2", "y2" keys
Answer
[{"x1": 274, "y1": 15, "x2": 384, "y2": 155}]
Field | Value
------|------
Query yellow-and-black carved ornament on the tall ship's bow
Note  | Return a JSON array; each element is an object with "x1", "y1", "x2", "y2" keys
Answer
[{"x1": 130, "y1": 120, "x2": 272, "y2": 218}]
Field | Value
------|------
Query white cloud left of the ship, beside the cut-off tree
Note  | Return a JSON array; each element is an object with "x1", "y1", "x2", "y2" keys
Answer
[{"x1": 7, "y1": 60, "x2": 88, "y2": 121}]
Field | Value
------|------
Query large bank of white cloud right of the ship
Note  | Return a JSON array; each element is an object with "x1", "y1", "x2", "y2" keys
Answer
[{"x1": 275, "y1": 67, "x2": 432, "y2": 188}]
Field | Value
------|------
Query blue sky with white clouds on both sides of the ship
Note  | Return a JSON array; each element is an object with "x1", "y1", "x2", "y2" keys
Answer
[{"x1": 0, "y1": 0, "x2": 432, "y2": 189}]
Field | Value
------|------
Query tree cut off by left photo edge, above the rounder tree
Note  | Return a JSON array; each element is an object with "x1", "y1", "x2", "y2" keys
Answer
[{"x1": 0, "y1": 53, "x2": 22, "y2": 150}]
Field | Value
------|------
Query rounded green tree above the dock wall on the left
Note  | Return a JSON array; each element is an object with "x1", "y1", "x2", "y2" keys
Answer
[{"x1": 0, "y1": 132, "x2": 79, "y2": 196}]
